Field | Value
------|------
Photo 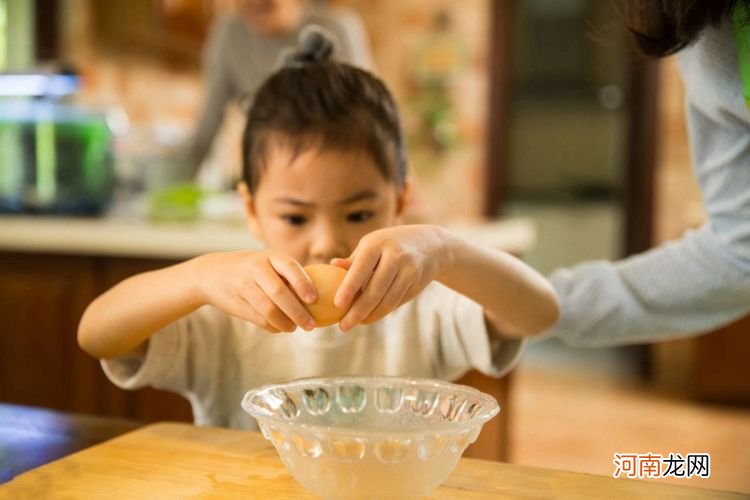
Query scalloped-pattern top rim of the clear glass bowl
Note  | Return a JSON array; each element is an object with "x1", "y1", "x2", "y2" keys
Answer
[{"x1": 241, "y1": 375, "x2": 500, "y2": 438}]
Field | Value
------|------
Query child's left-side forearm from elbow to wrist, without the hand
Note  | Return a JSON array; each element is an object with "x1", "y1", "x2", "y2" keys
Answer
[{"x1": 78, "y1": 261, "x2": 202, "y2": 358}]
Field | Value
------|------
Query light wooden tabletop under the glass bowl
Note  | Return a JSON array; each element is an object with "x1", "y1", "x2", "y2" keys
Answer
[{"x1": 0, "y1": 423, "x2": 745, "y2": 499}]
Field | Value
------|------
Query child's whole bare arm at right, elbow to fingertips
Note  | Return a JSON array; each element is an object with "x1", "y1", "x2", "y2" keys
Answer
[{"x1": 334, "y1": 225, "x2": 559, "y2": 337}]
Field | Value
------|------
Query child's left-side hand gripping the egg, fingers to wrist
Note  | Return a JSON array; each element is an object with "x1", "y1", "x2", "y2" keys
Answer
[{"x1": 195, "y1": 251, "x2": 317, "y2": 333}]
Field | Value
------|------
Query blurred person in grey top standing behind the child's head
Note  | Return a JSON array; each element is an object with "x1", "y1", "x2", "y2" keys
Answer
[{"x1": 184, "y1": 0, "x2": 373, "y2": 184}]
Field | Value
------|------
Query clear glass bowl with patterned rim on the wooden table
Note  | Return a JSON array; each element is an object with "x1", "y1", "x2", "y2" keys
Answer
[{"x1": 242, "y1": 377, "x2": 500, "y2": 499}]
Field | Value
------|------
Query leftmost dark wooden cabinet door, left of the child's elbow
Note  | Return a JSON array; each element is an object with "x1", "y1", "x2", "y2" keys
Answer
[{"x1": 0, "y1": 255, "x2": 94, "y2": 410}]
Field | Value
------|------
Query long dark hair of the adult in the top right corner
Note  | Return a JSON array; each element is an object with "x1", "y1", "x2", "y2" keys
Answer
[{"x1": 625, "y1": 0, "x2": 750, "y2": 57}]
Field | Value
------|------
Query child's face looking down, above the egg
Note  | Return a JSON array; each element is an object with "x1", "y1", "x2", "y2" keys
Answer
[{"x1": 244, "y1": 143, "x2": 406, "y2": 265}]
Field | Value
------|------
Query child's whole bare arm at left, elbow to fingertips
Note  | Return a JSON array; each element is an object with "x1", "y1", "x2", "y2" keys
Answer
[{"x1": 78, "y1": 252, "x2": 316, "y2": 358}]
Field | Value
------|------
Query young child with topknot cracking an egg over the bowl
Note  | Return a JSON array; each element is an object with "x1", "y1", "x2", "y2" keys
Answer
[{"x1": 78, "y1": 34, "x2": 558, "y2": 428}]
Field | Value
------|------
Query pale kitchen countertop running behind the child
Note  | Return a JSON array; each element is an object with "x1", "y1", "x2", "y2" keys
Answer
[{"x1": 0, "y1": 210, "x2": 536, "y2": 259}]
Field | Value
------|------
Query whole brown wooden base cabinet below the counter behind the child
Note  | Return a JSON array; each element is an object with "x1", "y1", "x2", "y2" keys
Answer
[{"x1": 0, "y1": 253, "x2": 510, "y2": 460}]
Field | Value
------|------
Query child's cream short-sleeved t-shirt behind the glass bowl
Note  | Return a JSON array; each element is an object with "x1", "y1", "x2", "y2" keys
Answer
[{"x1": 102, "y1": 282, "x2": 524, "y2": 428}]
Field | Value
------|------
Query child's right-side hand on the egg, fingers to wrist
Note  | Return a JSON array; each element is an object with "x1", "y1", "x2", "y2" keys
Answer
[{"x1": 331, "y1": 225, "x2": 449, "y2": 331}]
